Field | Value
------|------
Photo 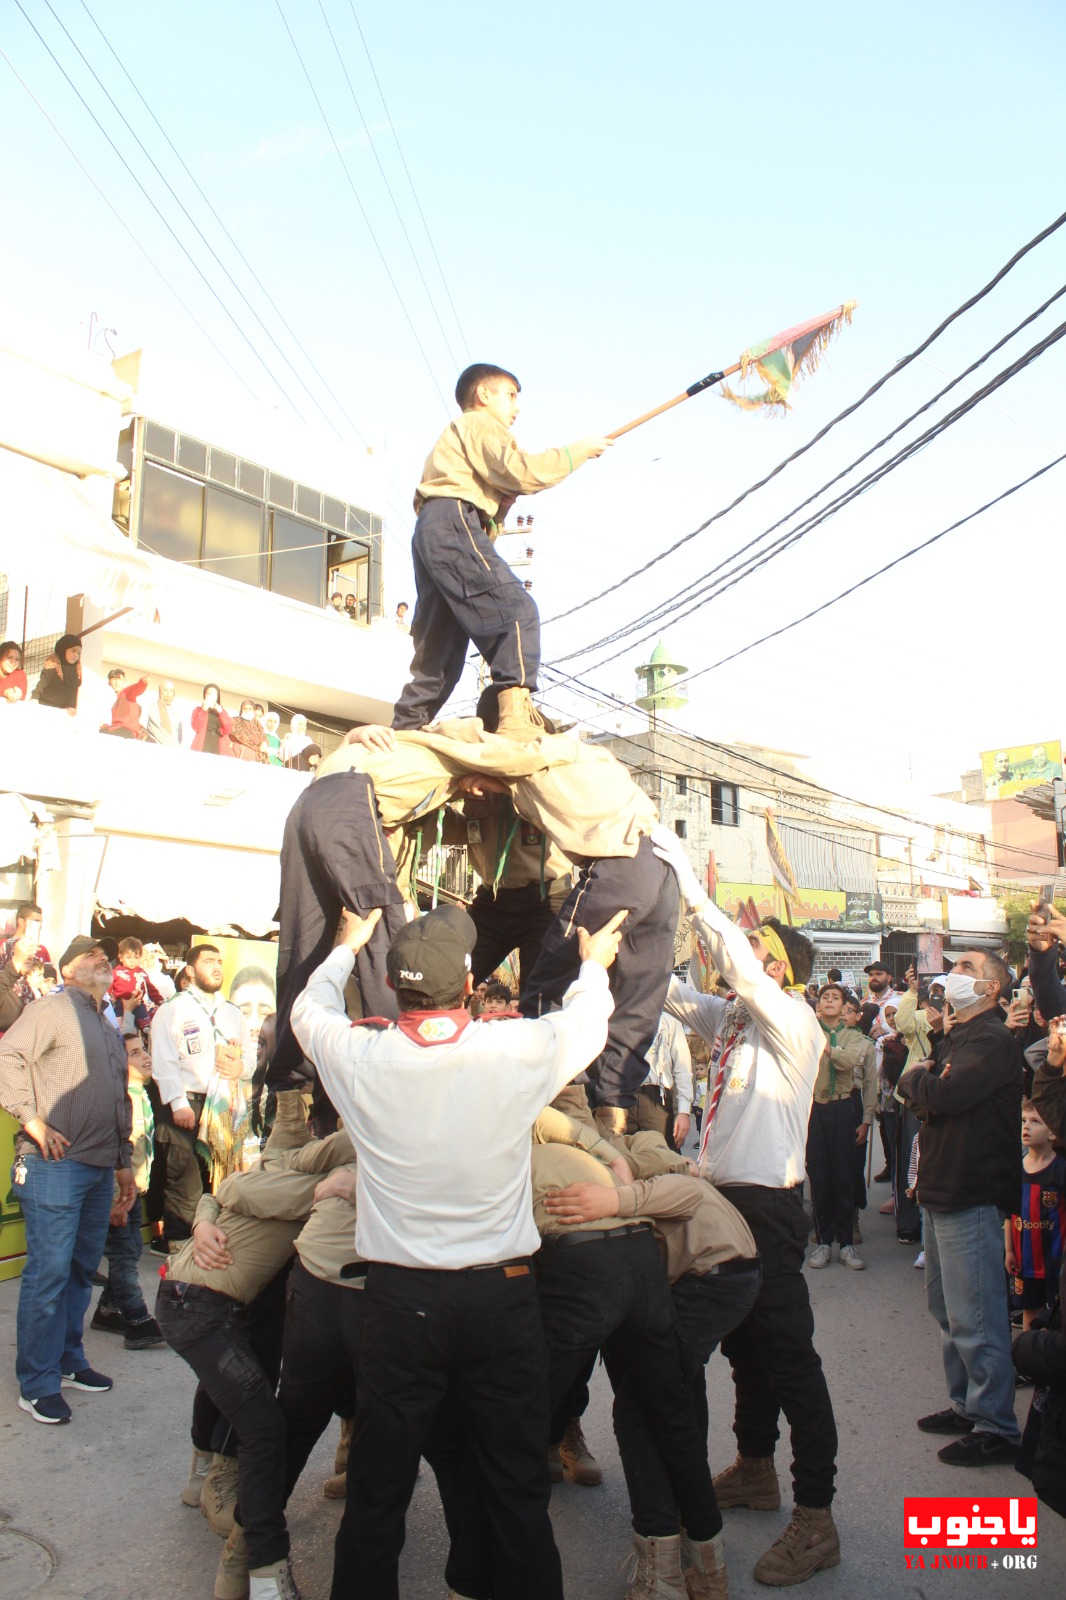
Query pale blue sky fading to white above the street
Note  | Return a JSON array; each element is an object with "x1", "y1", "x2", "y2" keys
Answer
[{"x1": 0, "y1": 0, "x2": 1066, "y2": 800}]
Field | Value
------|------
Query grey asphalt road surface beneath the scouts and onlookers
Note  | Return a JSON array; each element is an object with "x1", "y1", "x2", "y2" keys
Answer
[{"x1": 0, "y1": 1189, "x2": 1066, "y2": 1600}]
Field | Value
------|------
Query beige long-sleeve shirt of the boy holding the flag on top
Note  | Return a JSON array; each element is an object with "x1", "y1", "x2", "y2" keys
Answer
[{"x1": 415, "y1": 406, "x2": 589, "y2": 517}]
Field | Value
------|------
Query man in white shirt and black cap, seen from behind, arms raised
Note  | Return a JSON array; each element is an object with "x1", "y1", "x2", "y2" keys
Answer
[{"x1": 293, "y1": 907, "x2": 624, "y2": 1600}]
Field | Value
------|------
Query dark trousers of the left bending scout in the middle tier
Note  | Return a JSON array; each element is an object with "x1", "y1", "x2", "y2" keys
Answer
[{"x1": 267, "y1": 773, "x2": 405, "y2": 1088}]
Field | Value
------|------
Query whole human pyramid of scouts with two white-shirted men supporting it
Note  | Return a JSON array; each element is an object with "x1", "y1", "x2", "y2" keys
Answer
[{"x1": 157, "y1": 365, "x2": 840, "y2": 1600}]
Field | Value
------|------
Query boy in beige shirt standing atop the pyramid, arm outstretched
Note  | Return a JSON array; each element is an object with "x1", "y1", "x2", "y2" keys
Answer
[{"x1": 392, "y1": 362, "x2": 611, "y2": 739}]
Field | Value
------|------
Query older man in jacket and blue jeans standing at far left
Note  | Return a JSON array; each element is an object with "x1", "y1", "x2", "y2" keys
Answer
[{"x1": 0, "y1": 936, "x2": 136, "y2": 1424}]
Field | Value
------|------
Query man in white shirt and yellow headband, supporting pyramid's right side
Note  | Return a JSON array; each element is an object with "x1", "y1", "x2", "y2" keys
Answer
[{"x1": 653, "y1": 829, "x2": 840, "y2": 1584}]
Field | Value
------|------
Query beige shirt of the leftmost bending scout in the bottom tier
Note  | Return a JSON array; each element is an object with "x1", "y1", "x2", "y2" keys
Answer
[{"x1": 166, "y1": 1133, "x2": 354, "y2": 1306}]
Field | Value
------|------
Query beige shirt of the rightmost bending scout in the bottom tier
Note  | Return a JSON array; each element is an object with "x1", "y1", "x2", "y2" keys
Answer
[{"x1": 618, "y1": 1174, "x2": 759, "y2": 1283}]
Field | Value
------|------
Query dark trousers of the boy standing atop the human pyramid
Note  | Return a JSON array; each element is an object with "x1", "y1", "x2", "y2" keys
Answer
[{"x1": 392, "y1": 499, "x2": 541, "y2": 728}]
